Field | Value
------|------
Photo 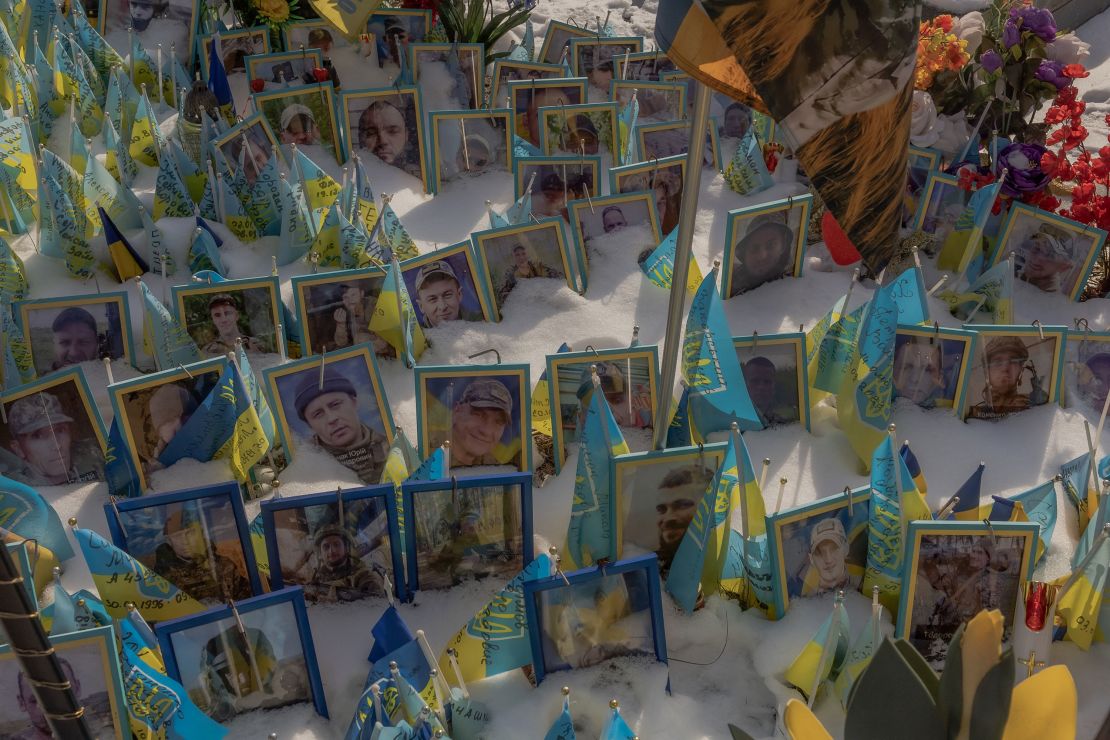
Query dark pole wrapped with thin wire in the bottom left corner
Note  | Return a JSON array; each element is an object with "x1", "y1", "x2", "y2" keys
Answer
[{"x1": 0, "y1": 547, "x2": 92, "y2": 740}]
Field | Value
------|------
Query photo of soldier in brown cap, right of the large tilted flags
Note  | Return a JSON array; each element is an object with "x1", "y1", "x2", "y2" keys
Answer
[{"x1": 968, "y1": 336, "x2": 1055, "y2": 418}]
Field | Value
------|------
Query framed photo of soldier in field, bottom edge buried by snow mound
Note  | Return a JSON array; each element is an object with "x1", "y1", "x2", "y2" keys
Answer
[{"x1": 471, "y1": 219, "x2": 577, "y2": 322}]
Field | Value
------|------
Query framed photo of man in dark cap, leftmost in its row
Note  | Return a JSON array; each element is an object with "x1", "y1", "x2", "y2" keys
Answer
[{"x1": 13, "y1": 292, "x2": 135, "y2": 376}]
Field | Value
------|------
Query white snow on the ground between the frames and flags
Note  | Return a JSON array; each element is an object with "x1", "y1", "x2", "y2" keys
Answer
[{"x1": 6, "y1": 0, "x2": 1110, "y2": 740}]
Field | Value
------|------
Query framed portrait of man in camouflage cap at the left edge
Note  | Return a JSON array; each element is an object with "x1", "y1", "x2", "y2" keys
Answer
[{"x1": 0, "y1": 388, "x2": 104, "y2": 487}]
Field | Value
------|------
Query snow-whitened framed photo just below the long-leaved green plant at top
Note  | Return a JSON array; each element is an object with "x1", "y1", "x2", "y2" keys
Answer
[{"x1": 410, "y1": 43, "x2": 486, "y2": 111}]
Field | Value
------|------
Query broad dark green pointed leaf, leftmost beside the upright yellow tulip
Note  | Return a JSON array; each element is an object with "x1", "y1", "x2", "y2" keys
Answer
[{"x1": 844, "y1": 638, "x2": 945, "y2": 740}]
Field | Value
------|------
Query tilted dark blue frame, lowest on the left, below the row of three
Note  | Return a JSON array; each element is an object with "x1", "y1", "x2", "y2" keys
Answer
[{"x1": 154, "y1": 586, "x2": 329, "y2": 718}]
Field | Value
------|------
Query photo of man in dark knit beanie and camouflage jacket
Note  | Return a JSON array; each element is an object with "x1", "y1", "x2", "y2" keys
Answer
[{"x1": 290, "y1": 366, "x2": 390, "y2": 484}]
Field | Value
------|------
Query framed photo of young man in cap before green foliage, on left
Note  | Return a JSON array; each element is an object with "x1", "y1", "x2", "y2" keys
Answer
[{"x1": 173, "y1": 277, "x2": 284, "y2": 357}]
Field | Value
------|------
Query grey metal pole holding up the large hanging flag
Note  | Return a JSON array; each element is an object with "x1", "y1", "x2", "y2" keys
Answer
[{"x1": 653, "y1": 80, "x2": 709, "y2": 449}]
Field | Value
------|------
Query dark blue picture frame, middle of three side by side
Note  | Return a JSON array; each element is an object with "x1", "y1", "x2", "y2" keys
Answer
[{"x1": 262, "y1": 484, "x2": 407, "y2": 601}]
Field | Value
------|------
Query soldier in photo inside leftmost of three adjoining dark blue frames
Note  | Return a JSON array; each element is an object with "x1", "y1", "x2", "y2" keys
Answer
[{"x1": 154, "y1": 504, "x2": 252, "y2": 605}]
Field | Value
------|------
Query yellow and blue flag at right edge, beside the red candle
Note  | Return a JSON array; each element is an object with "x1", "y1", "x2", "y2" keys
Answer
[{"x1": 1056, "y1": 525, "x2": 1110, "y2": 650}]
